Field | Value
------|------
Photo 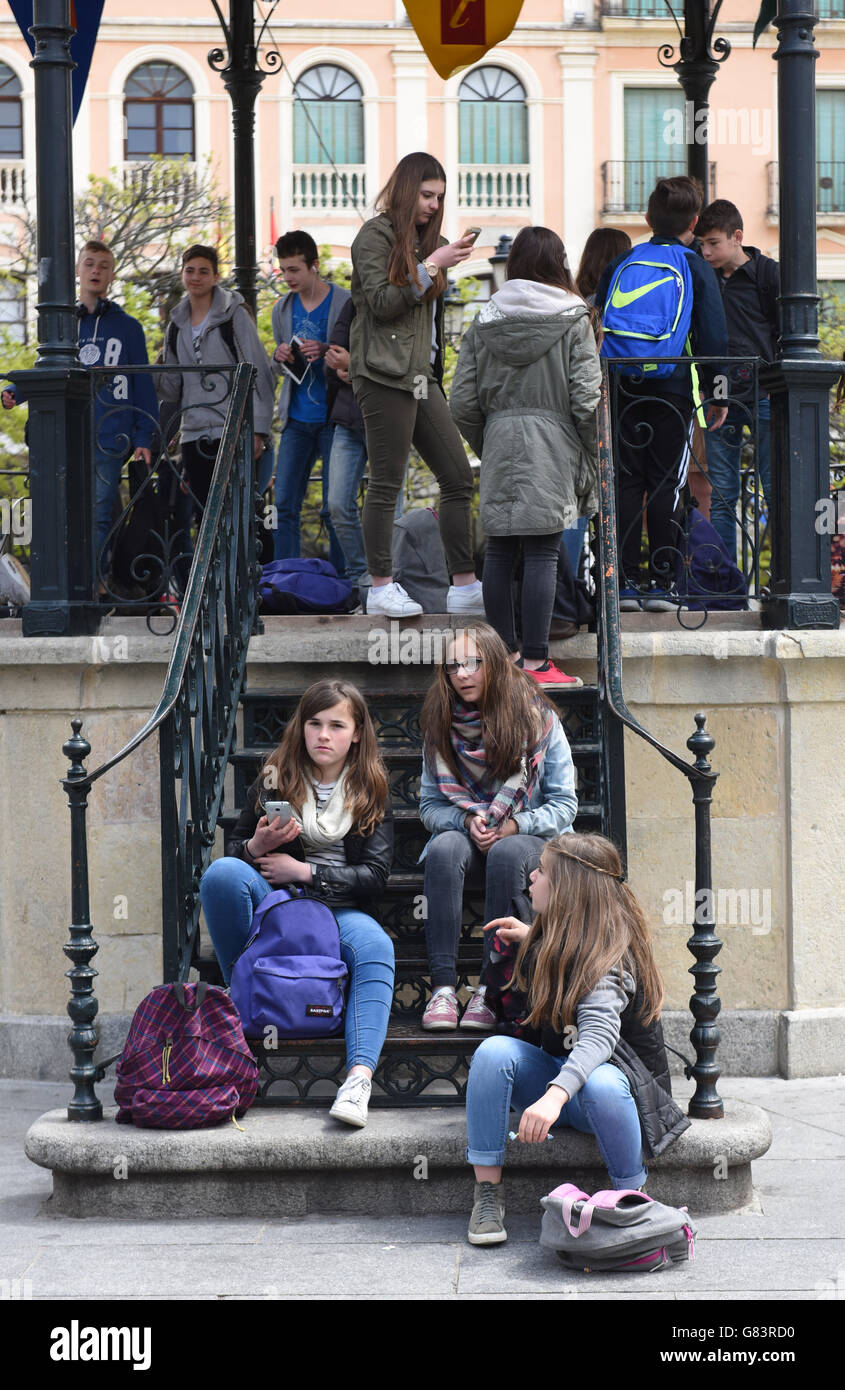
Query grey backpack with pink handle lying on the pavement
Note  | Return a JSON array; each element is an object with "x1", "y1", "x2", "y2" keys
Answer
[{"x1": 539, "y1": 1183, "x2": 695, "y2": 1273}]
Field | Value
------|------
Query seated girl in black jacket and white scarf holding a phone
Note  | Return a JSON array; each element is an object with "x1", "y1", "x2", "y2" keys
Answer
[{"x1": 200, "y1": 680, "x2": 393, "y2": 1127}]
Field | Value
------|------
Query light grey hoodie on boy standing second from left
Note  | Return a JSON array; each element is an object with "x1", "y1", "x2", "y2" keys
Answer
[{"x1": 158, "y1": 285, "x2": 275, "y2": 442}]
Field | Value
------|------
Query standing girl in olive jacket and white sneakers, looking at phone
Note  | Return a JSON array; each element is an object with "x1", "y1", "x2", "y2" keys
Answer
[{"x1": 349, "y1": 152, "x2": 484, "y2": 617}]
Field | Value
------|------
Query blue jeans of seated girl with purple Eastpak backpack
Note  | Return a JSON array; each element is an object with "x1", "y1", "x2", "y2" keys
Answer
[{"x1": 200, "y1": 856, "x2": 393, "y2": 1070}]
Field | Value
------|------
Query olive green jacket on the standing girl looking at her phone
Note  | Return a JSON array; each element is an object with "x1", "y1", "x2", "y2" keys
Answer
[{"x1": 349, "y1": 213, "x2": 446, "y2": 391}]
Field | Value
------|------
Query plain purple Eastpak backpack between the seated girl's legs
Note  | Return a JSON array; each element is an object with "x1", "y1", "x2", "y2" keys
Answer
[{"x1": 231, "y1": 885, "x2": 346, "y2": 1038}]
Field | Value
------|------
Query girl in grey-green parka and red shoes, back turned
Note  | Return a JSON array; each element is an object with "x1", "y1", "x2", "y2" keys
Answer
[{"x1": 449, "y1": 227, "x2": 602, "y2": 687}]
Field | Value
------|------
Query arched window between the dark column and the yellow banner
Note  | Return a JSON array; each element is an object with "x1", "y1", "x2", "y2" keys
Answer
[{"x1": 293, "y1": 63, "x2": 364, "y2": 164}]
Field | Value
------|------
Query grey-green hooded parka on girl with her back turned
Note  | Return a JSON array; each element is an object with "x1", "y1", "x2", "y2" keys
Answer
[{"x1": 449, "y1": 279, "x2": 602, "y2": 535}]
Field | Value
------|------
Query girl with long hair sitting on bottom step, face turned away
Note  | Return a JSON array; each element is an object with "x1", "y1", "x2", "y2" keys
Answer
[{"x1": 467, "y1": 834, "x2": 669, "y2": 1245}]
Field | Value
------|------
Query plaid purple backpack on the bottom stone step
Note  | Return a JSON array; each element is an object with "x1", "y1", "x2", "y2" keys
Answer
[{"x1": 114, "y1": 980, "x2": 259, "y2": 1129}]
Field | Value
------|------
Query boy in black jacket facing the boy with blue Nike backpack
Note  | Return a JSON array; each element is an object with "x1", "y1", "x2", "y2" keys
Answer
[{"x1": 696, "y1": 197, "x2": 781, "y2": 560}]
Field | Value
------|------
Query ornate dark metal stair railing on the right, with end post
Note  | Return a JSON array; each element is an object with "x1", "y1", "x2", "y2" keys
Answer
[{"x1": 596, "y1": 363, "x2": 724, "y2": 1119}]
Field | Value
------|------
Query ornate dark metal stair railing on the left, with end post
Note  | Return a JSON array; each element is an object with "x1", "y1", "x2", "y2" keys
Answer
[{"x1": 63, "y1": 363, "x2": 259, "y2": 1120}]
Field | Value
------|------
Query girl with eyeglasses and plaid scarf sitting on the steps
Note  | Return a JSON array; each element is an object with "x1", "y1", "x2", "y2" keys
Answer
[{"x1": 420, "y1": 623, "x2": 578, "y2": 1031}]
